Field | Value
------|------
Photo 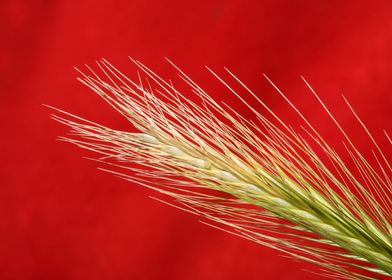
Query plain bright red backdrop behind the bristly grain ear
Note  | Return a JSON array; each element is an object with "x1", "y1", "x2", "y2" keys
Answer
[{"x1": 0, "y1": 0, "x2": 392, "y2": 280}]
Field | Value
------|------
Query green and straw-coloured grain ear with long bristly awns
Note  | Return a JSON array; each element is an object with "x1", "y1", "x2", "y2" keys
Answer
[{"x1": 49, "y1": 60, "x2": 392, "y2": 279}]
